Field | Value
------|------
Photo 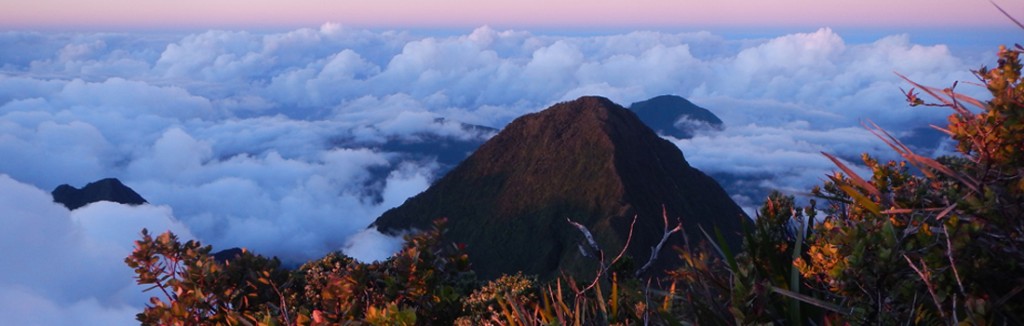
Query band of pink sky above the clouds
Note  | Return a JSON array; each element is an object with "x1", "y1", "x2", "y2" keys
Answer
[{"x1": 0, "y1": 0, "x2": 1024, "y2": 30}]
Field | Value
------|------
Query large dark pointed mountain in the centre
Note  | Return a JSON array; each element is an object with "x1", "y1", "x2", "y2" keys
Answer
[{"x1": 372, "y1": 96, "x2": 746, "y2": 278}]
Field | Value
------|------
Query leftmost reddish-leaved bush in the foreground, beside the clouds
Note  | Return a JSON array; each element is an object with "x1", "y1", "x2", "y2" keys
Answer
[{"x1": 125, "y1": 230, "x2": 292, "y2": 325}]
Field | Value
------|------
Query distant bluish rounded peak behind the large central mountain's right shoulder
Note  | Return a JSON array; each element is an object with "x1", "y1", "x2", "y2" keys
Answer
[{"x1": 630, "y1": 95, "x2": 724, "y2": 139}]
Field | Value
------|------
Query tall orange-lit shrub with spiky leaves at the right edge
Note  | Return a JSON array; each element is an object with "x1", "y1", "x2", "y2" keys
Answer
[{"x1": 797, "y1": 46, "x2": 1024, "y2": 324}]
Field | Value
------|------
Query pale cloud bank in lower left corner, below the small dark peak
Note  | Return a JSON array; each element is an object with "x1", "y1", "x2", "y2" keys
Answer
[{"x1": 0, "y1": 174, "x2": 194, "y2": 325}]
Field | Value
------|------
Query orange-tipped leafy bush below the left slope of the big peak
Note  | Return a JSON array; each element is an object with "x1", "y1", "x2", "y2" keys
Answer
[{"x1": 311, "y1": 219, "x2": 475, "y2": 325}]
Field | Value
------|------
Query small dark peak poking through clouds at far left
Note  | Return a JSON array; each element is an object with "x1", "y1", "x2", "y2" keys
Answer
[{"x1": 50, "y1": 178, "x2": 146, "y2": 210}]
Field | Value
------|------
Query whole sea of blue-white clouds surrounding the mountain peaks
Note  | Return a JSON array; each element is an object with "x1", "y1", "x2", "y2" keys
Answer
[{"x1": 0, "y1": 24, "x2": 996, "y2": 324}]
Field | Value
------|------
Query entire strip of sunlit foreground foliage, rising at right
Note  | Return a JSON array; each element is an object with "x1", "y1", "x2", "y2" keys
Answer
[{"x1": 126, "y1": 46, "x2": 1024, "y2": 325}]
